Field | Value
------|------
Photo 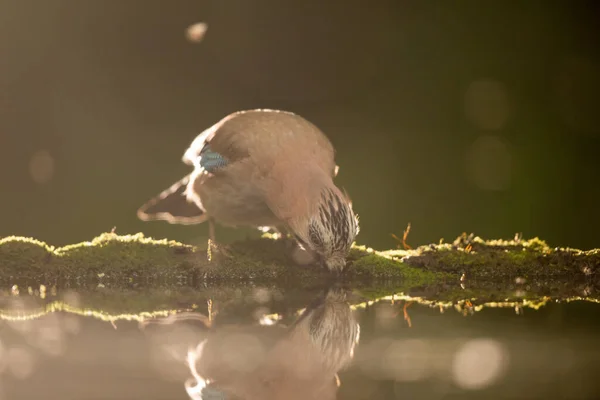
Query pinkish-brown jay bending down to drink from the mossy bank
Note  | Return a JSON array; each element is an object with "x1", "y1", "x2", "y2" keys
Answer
[{"x1": 137, "y1": 109, "x2": 359, "y2": 272}]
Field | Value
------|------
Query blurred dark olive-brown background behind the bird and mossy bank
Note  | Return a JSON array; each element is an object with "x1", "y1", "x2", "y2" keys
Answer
[{"x1": 0, "y1": 0, "x2": 600, "y2": 248}]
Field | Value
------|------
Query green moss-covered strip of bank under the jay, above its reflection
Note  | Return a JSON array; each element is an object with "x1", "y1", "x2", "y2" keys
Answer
[{"x1": 0, "y1": 233, "x2": 600, "y2": 287}]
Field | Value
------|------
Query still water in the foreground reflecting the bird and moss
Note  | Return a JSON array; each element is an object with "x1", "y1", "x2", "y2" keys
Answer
[{"x1": 0, "y1": 285, "x2": 600, "y2": 400}]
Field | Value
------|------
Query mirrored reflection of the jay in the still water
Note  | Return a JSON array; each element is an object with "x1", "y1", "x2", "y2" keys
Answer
[{"x1": 186, "y1": 287, "x2": 360, "y2": 400}]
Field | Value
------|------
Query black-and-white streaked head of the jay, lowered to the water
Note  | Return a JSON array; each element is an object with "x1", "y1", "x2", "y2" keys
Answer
[{"x1": 294, "y1": 185, "x2": 359, "y2": 272}]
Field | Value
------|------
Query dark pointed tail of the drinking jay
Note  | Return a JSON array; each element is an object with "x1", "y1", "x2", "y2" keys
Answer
[{"x1": 137, "y1": 174, "x2": 208, "y2": 225}]
